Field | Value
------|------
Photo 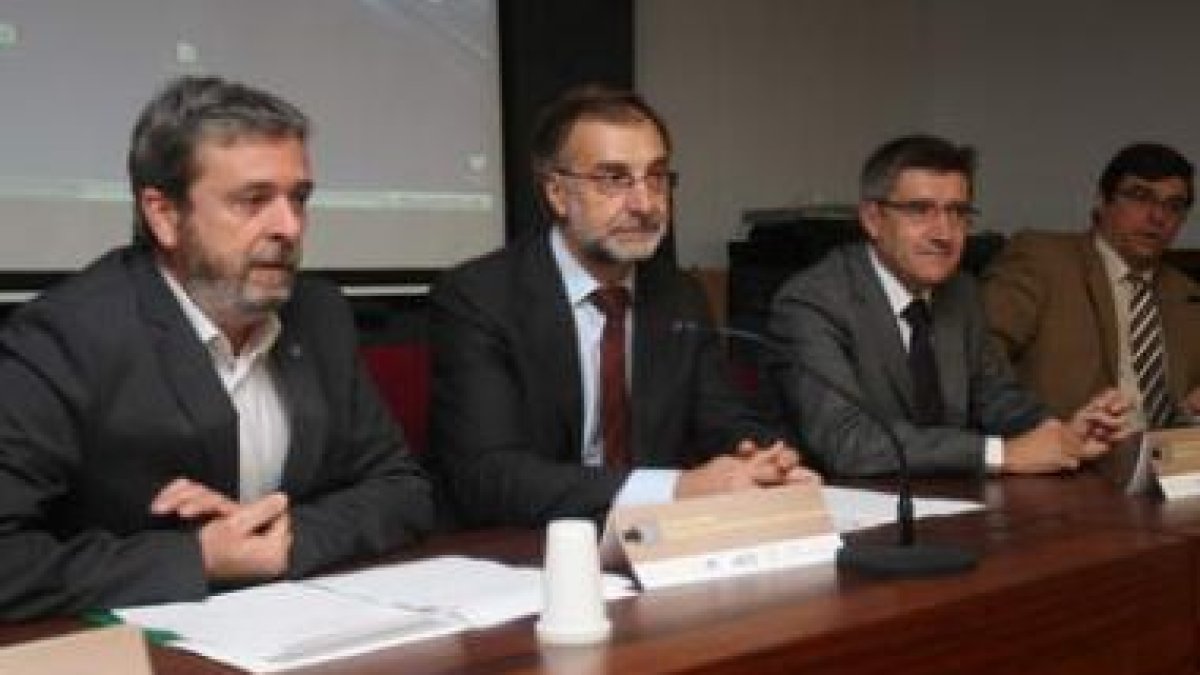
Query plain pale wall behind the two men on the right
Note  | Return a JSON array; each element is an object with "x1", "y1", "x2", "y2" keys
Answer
[{"x1": 636, "y1": 0, "x2": 1200, "y2": 267}]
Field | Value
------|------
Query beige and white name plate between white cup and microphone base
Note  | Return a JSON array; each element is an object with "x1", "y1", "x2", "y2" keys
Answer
[{"x1": 606, "y1": 485, "x2": 841, "y2": 590}]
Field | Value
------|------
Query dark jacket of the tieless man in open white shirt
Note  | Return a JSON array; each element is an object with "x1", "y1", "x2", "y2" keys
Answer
[{"x1": 0, "y1": 249, "x2": 432, "y2": 617}]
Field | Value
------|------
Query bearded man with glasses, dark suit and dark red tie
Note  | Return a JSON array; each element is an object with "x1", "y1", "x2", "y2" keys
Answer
[{"x1": 431, "y1": 86, "x2": 814, "y2": 526}]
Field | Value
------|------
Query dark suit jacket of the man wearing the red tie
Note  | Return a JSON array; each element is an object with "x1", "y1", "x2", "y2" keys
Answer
[{"x1": 431, "y1": 229, "x2": 774, "y2": 525}]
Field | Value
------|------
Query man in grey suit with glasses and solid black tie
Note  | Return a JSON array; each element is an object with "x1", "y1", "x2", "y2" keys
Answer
[{"x1": 770, "y1": 136, "x2": 1124, "y2": 476}]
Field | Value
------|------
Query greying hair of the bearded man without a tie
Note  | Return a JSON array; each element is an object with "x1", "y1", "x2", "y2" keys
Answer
[{"x1": 127, "y1": 76, "x2": 308, "y2": 245}]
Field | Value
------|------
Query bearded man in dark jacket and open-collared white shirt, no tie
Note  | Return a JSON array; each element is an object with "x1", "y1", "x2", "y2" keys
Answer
[{"x1": 0, "y1": 78, "x2": 432, "y2": 619}]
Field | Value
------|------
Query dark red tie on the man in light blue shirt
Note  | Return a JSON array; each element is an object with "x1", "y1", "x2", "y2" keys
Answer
[{"x1": 590, "y1": 286, "x2": 632, "y2": 468}]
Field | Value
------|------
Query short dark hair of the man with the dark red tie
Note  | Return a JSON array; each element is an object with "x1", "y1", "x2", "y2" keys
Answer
[{"x1": 529, "y1": 84, "x2": 671, "y2": 180}]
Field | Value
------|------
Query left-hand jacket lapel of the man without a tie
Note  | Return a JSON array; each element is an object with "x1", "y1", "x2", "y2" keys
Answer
[{"x1": 130, "y1": 253, "x2": 239, "y2": 497}]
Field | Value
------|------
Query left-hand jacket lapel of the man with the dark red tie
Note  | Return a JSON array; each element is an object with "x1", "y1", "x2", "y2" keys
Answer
[{"x1": 518, "y1": 231, "x2": 583, "y2": 461}]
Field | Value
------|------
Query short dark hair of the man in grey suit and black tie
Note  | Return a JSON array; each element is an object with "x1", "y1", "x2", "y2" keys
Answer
[{"x1": 859, "y1": 133, "x2": 976, "y2": 202}]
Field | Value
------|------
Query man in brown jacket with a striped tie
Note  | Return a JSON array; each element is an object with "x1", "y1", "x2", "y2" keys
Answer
[{"x1": 983, "y1": 143, "x2": 1200, "y2": 429}]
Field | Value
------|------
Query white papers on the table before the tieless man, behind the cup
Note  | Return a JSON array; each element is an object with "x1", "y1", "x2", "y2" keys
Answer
[{"x1": 116, "y1": 556, "x2": 634, "y2": 673}]
